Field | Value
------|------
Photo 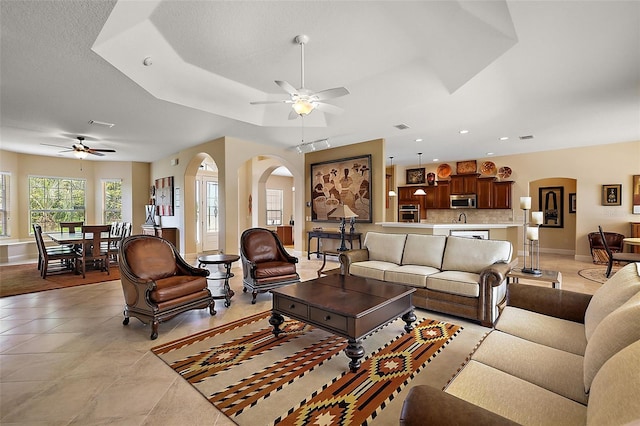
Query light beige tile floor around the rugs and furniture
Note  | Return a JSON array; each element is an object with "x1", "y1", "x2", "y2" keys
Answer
[{"x1": 0, "y1": 251, "x2": 600, "y2": 426}]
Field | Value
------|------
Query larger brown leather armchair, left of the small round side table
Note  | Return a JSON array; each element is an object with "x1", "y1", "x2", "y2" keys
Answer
[{"x1": 118, "y1": 235, "x2": 216, "y2": 340}]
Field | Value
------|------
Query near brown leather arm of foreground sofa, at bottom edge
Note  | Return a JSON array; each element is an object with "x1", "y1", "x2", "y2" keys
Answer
[{"x1": 400, "y1": 385, "x2": 517, "y2": 426}]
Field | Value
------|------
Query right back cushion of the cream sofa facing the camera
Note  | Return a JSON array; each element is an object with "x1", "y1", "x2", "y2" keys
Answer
[{"x1": 442, "y1": 237, "x2": 513, "y2": 274}]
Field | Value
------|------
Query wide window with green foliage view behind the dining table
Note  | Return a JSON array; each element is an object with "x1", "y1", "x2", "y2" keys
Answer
[{"x1": 29, "y1": 176, "x2": 87, "y2": 232}]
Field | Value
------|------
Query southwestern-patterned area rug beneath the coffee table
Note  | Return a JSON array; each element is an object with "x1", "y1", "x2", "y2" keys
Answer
[{"x1": 152, "y1": 312, "x2": 464, "y2": 425}]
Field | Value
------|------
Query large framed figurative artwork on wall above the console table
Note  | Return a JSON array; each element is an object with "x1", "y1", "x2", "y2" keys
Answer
[{"x1": 311, "y1": 154, "x2": 372, "y2": 222}]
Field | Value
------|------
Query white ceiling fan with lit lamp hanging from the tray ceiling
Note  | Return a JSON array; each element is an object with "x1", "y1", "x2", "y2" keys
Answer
[{"x1": 251, "y1": 35, "x2": 349, "y2": 120}]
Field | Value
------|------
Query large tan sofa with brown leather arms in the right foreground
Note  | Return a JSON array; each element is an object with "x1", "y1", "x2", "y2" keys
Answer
[{"x1": 400, "y1": 263, "x2": 640, "y2": 426}]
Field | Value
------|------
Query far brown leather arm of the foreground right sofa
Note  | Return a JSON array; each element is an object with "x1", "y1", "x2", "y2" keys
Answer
[{"x1": 507, "y1": 284, "x2": 592, "y2": 323}]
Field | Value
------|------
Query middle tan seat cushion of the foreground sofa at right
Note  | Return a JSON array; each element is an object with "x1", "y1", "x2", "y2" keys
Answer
[{"x1": 473, "y1": 330, "x2": 588, "y2": 405}]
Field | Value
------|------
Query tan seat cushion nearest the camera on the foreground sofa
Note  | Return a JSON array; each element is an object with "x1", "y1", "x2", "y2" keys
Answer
[{"x1": 446, "y1": 360, "x2": 587, "y2": 426}]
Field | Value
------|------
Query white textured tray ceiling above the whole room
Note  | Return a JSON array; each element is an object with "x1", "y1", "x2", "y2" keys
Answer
[{"x1": 0, "y1": 0, "x2": 640, "y2": 165}]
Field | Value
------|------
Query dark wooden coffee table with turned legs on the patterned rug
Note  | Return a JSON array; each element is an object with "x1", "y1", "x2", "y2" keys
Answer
[{"x1": 269, "y1": 275, "x2": 416, "y2": 373}]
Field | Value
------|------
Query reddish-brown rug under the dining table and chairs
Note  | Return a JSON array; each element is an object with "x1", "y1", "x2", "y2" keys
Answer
[{"x1": 0, "y1": 263, "x2": 120, "y2": 297}]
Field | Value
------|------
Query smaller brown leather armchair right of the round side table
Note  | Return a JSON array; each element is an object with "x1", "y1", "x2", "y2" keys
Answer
[{"x1": 240, "y1": 228, "x2": 300, "y2": 304}]
